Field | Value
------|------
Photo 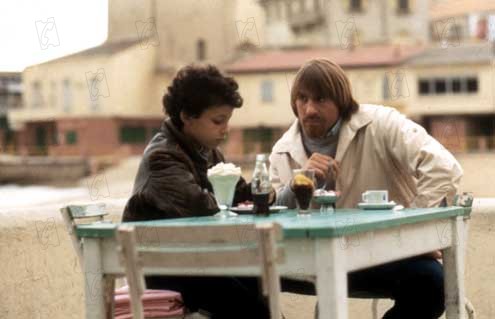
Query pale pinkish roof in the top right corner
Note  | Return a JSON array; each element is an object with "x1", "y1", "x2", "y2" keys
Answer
[{"x1": 430, "y1": 0, "x2": 495, "y2": 20}]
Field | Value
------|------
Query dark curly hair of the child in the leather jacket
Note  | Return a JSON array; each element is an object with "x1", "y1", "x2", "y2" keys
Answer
[{"x1": 162, "y1": 64, "x2": 243, "y2": 129}]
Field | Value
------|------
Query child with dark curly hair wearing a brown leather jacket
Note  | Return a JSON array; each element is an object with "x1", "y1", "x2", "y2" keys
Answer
[{"x1": 123, "y1": 65, "x2": 269, "y2": 318}]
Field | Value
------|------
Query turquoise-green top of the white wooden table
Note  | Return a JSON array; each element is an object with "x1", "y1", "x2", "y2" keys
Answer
[{"x1": 76, "y1": 206, "x2": 471, "y2": 238}]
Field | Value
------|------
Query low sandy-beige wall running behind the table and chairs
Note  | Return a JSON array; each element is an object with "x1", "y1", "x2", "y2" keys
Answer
[{"x1": 0, "y1": 199, "x2": 495, "y2": 319}]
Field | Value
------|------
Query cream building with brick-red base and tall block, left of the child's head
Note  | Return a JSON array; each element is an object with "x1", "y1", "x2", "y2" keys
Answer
[{"x1": 8, "y1": 0, "x2": 263, "y2": 156}]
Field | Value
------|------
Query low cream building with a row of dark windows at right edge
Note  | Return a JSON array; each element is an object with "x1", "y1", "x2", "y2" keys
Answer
[{"x1": 407, "y1": 43, "x2": 495, "y2": 152}]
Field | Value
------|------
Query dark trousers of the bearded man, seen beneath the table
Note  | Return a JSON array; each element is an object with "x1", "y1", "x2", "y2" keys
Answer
[{"x1": 282, "y1": 256, "x2": 445, "y2": 319}]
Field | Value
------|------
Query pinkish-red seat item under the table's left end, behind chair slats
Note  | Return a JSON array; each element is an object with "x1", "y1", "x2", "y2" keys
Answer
[{"x1": 114, "y1": 286, "x2": 185, "y2": 319}]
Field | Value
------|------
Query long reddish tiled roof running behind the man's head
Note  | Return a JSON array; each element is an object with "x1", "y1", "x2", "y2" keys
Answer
[{"x1": 224, "y1": 45, "x2": 424, "y2": 73}]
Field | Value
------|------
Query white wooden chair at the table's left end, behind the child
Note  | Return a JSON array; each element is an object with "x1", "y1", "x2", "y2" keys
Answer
[{"x1": 60, "y1": 203, "x2": 186, "y2": 319}]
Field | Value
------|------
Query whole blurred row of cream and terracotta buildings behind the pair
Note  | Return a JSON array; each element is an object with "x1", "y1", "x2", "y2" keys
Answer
[{"x1": 8, "y1": 0, "x2": 495, "y2": 160}]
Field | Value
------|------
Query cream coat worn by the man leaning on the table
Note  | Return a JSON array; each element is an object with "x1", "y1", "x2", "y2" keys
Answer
[{"x1": 270, "y1": 104, "x2": 463, "y2": 208}]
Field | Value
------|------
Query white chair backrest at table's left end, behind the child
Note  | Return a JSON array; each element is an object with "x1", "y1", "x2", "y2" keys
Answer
[{"x1": 60, "y1": 203, "x2": 108, "y2": 266}]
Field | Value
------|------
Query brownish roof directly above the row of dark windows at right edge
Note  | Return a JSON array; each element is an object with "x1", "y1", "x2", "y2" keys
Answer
[{"x1": 408, "y1": 42, "x2": 494, "y2": 65}]
